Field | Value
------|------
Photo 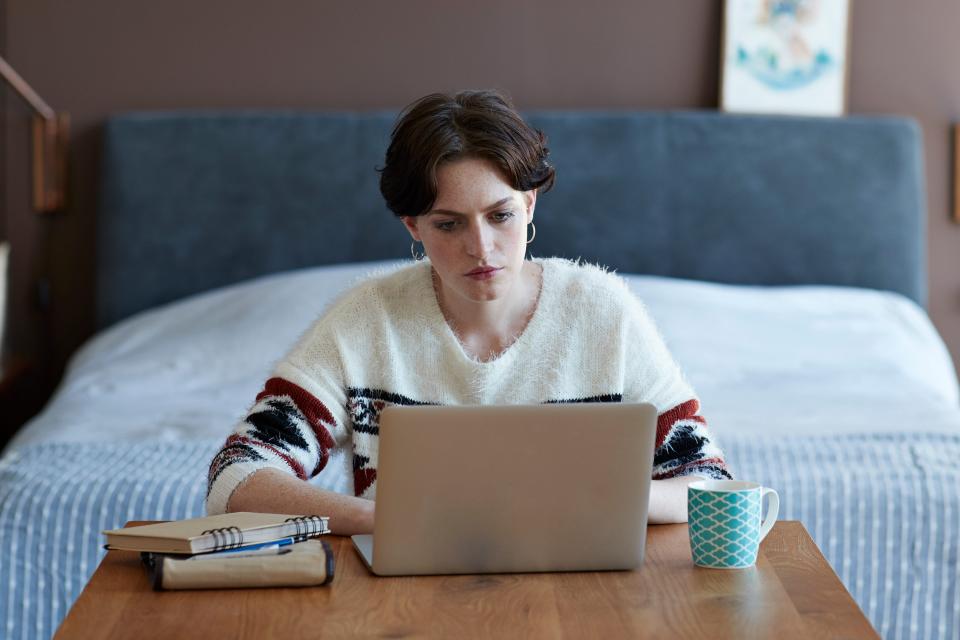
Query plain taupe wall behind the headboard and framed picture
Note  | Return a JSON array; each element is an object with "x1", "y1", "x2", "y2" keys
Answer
[{"x1": 0, "y1": 0, "x2": 960, "y2": 400}]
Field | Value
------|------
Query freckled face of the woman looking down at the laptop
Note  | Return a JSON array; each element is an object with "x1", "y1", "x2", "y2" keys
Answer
[{"x1": 402, "y1": 158, "x2": 537, "y2": 302}]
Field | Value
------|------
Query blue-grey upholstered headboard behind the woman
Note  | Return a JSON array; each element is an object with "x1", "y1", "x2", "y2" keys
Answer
[{"x1": 97, "y1": 112, "x2": 926, "y2": 326}]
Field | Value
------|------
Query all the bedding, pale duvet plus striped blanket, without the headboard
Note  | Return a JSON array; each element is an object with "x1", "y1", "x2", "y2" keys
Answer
[{"x1": 0, "y1": 264, "x2": 960, "y2": 638}]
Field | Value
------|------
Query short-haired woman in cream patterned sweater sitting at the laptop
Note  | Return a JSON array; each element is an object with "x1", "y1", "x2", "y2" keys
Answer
[{"x1": 207, "y1": 87, "x2": 729, "y2": 535}]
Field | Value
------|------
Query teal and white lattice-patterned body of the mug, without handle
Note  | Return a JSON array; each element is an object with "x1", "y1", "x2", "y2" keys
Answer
[{"x1": 689, "y1": 491, "x2": 760, "y2": 567}]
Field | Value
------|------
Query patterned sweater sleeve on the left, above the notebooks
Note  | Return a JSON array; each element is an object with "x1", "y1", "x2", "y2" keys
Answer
[{"x1": 206, "y1": 326, "x2": 346, "y2": 515}]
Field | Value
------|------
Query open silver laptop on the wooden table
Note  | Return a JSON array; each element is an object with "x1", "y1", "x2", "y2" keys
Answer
[{"x1": 353, "y1": 403, "x2": 657, "y2": 576}]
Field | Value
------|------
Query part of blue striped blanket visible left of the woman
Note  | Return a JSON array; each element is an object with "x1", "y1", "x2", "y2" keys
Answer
[{"x1": 0, "y1": 441, "x2": 217, "y2": 639}]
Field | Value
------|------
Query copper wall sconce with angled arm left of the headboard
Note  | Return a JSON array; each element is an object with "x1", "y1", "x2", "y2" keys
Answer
[{"x1": 0, "y1": 53, "x2": 70, "y2": 212}]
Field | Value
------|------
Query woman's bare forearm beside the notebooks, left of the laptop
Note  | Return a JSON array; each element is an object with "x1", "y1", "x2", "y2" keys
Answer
[{"x1": 227, "y1": 468, "x2": 376, "y2": 536}]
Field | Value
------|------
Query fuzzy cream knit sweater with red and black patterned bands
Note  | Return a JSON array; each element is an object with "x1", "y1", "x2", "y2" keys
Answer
[{"x1": 207, "y1": 258, "x2": 729, "y2": 514}]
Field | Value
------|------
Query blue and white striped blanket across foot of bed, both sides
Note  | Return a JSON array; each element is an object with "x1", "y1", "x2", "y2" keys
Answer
[{"x1": 0, "y1": 434, "x2": 960, "y2": 639}]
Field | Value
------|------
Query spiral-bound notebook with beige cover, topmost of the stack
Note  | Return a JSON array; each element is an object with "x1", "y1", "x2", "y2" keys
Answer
[{"x1": 103, "y1": 511, "x2": 330, "y2": 554}]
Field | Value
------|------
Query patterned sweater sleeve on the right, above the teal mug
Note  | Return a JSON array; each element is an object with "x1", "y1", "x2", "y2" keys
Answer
[{"x1": 624, "y1": 293, "x2": 732, "y2": 480}]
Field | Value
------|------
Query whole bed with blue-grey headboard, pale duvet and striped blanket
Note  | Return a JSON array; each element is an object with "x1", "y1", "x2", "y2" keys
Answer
[{"x1": 0, "y1": 112, "x2": 960, "y2": 638}]
